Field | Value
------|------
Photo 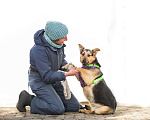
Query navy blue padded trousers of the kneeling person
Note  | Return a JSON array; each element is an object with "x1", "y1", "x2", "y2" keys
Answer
[{"x1": 29, "y1": 71, "x2": 80, "y2": 115}]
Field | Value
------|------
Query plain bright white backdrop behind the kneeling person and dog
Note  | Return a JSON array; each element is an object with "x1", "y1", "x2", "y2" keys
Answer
[{"x1": 0, "y1": 0, "x2": 150, "y2": 106}]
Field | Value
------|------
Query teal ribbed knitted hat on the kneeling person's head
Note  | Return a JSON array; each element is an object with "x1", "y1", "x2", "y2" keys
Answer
[{"x1": 45, "y1": 21, "x2": 68, "y2": 40}]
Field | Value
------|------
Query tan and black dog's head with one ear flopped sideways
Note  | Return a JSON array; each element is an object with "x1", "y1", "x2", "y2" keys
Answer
[{"x1": 79, "y1": 44, "x2": 100, "y2": 65}]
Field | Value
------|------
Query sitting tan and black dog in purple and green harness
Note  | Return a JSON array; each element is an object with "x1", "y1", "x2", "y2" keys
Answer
[{"x1": 61, "y1": 44, "x2": 117, "y2": 114}]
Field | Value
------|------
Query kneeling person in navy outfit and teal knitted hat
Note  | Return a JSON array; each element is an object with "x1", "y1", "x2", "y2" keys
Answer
[{"x1": 16, "y1": 21, "x2": 80, "y2": 115}]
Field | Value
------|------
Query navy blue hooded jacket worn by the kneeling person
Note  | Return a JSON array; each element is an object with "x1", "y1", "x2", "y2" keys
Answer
[{"x1": 29, "y1": 29, "x2": 67, "y2": 84}]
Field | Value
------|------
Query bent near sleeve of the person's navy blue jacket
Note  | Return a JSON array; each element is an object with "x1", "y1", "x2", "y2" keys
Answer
[{"x1": 33, "y1": 48, "x2": 66, "y2": 84}]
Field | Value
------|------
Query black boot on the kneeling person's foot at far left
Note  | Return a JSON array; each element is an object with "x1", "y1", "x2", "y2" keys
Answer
[{"x1": 16, "y1": 90, "x2": 34, "y2": 112}]
